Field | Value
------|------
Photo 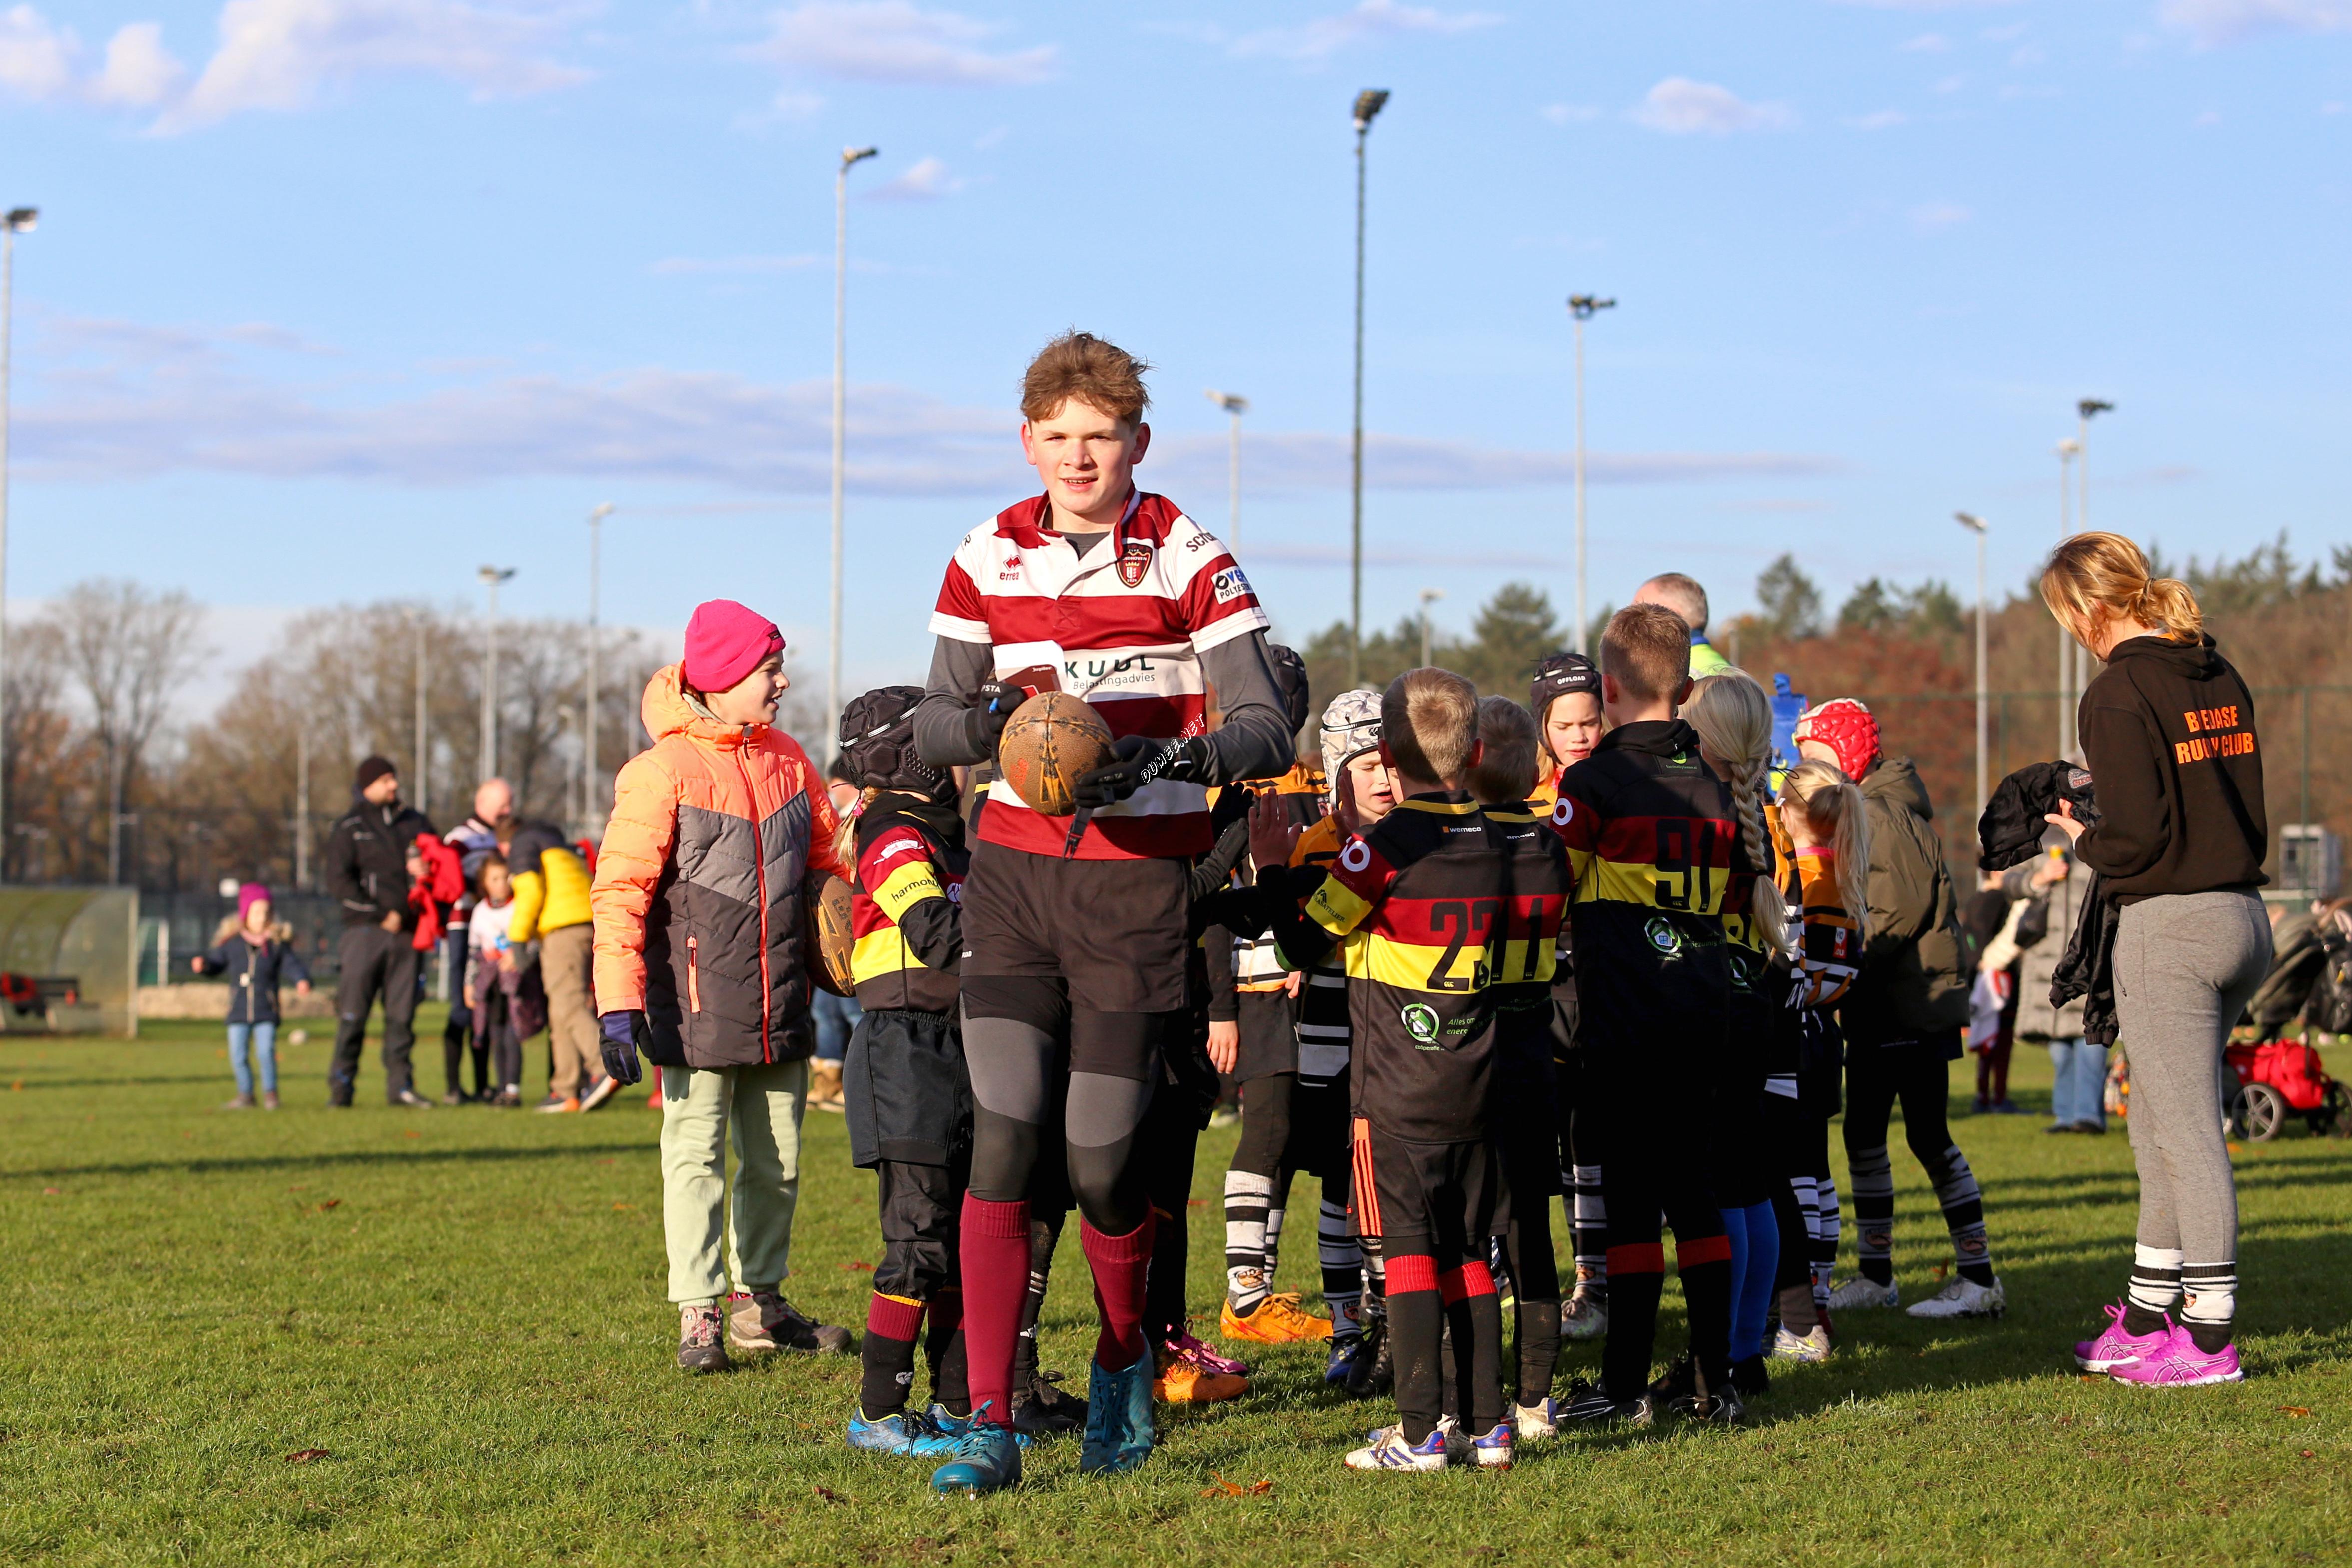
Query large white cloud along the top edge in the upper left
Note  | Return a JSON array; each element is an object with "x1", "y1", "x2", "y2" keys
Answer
[{"x1": 162, "y1": 0, "x2": 588, "y2": 129}]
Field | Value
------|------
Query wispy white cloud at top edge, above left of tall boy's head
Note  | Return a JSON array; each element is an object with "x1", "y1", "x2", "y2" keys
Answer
[{"x1": 748, "y1": 0, "x2": 1059, "y2": 87}]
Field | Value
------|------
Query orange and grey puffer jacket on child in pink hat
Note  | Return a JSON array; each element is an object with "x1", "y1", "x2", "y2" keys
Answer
[{"x1": 588, "y1": 665, "x2": 847, "y2": 1067}]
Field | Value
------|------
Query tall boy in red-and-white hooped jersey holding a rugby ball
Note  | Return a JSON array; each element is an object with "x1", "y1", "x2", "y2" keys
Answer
[{"x1": 915, "y1": 334, "x2": 1293, "y2": 1493}]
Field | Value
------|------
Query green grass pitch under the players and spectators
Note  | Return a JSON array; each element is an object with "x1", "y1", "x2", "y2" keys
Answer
[{"x1": 0, "y1": 1023, "x2": 2352, "y2": 1564}]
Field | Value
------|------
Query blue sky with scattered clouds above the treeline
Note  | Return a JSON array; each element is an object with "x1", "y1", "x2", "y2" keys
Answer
[{"x1": 0, "y1": 0, "x2": 2352, "y2": 700}]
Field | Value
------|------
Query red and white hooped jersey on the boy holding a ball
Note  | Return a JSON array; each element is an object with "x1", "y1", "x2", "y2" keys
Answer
[{"x1": 932, "y1": 491, "x2": 1268, "y2": 860}]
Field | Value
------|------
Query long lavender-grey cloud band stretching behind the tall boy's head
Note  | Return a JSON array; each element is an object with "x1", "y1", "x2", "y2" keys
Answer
[{"x1": 16, "y1": 320, "x2": 1842, "y2": 496}]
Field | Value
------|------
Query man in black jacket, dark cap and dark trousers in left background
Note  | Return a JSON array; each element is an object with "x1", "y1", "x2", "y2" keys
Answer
[{"x1": 327, "y1": 757, "x2": 433, "y2": 1107}]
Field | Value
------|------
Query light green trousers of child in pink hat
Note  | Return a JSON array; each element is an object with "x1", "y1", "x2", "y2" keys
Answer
[{"x1": 661, "y1": 1063, "x2": 809, "y2": 1307}]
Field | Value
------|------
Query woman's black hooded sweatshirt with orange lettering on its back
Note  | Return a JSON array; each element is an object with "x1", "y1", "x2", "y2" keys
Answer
[{"x1": 2075, "y1": 637, "x2": 2270, "y2": 903}]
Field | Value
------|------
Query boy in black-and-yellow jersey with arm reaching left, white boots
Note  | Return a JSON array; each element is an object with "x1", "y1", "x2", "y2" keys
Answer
[{"x1": 1213, "y1": 668, "x2": 1512, "y2": 1472}]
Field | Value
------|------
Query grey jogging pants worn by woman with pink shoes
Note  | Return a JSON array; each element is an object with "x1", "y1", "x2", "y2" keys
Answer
[{"x1": 2115, "y1": 893, "x2": 2270, "y2": 1262}]
